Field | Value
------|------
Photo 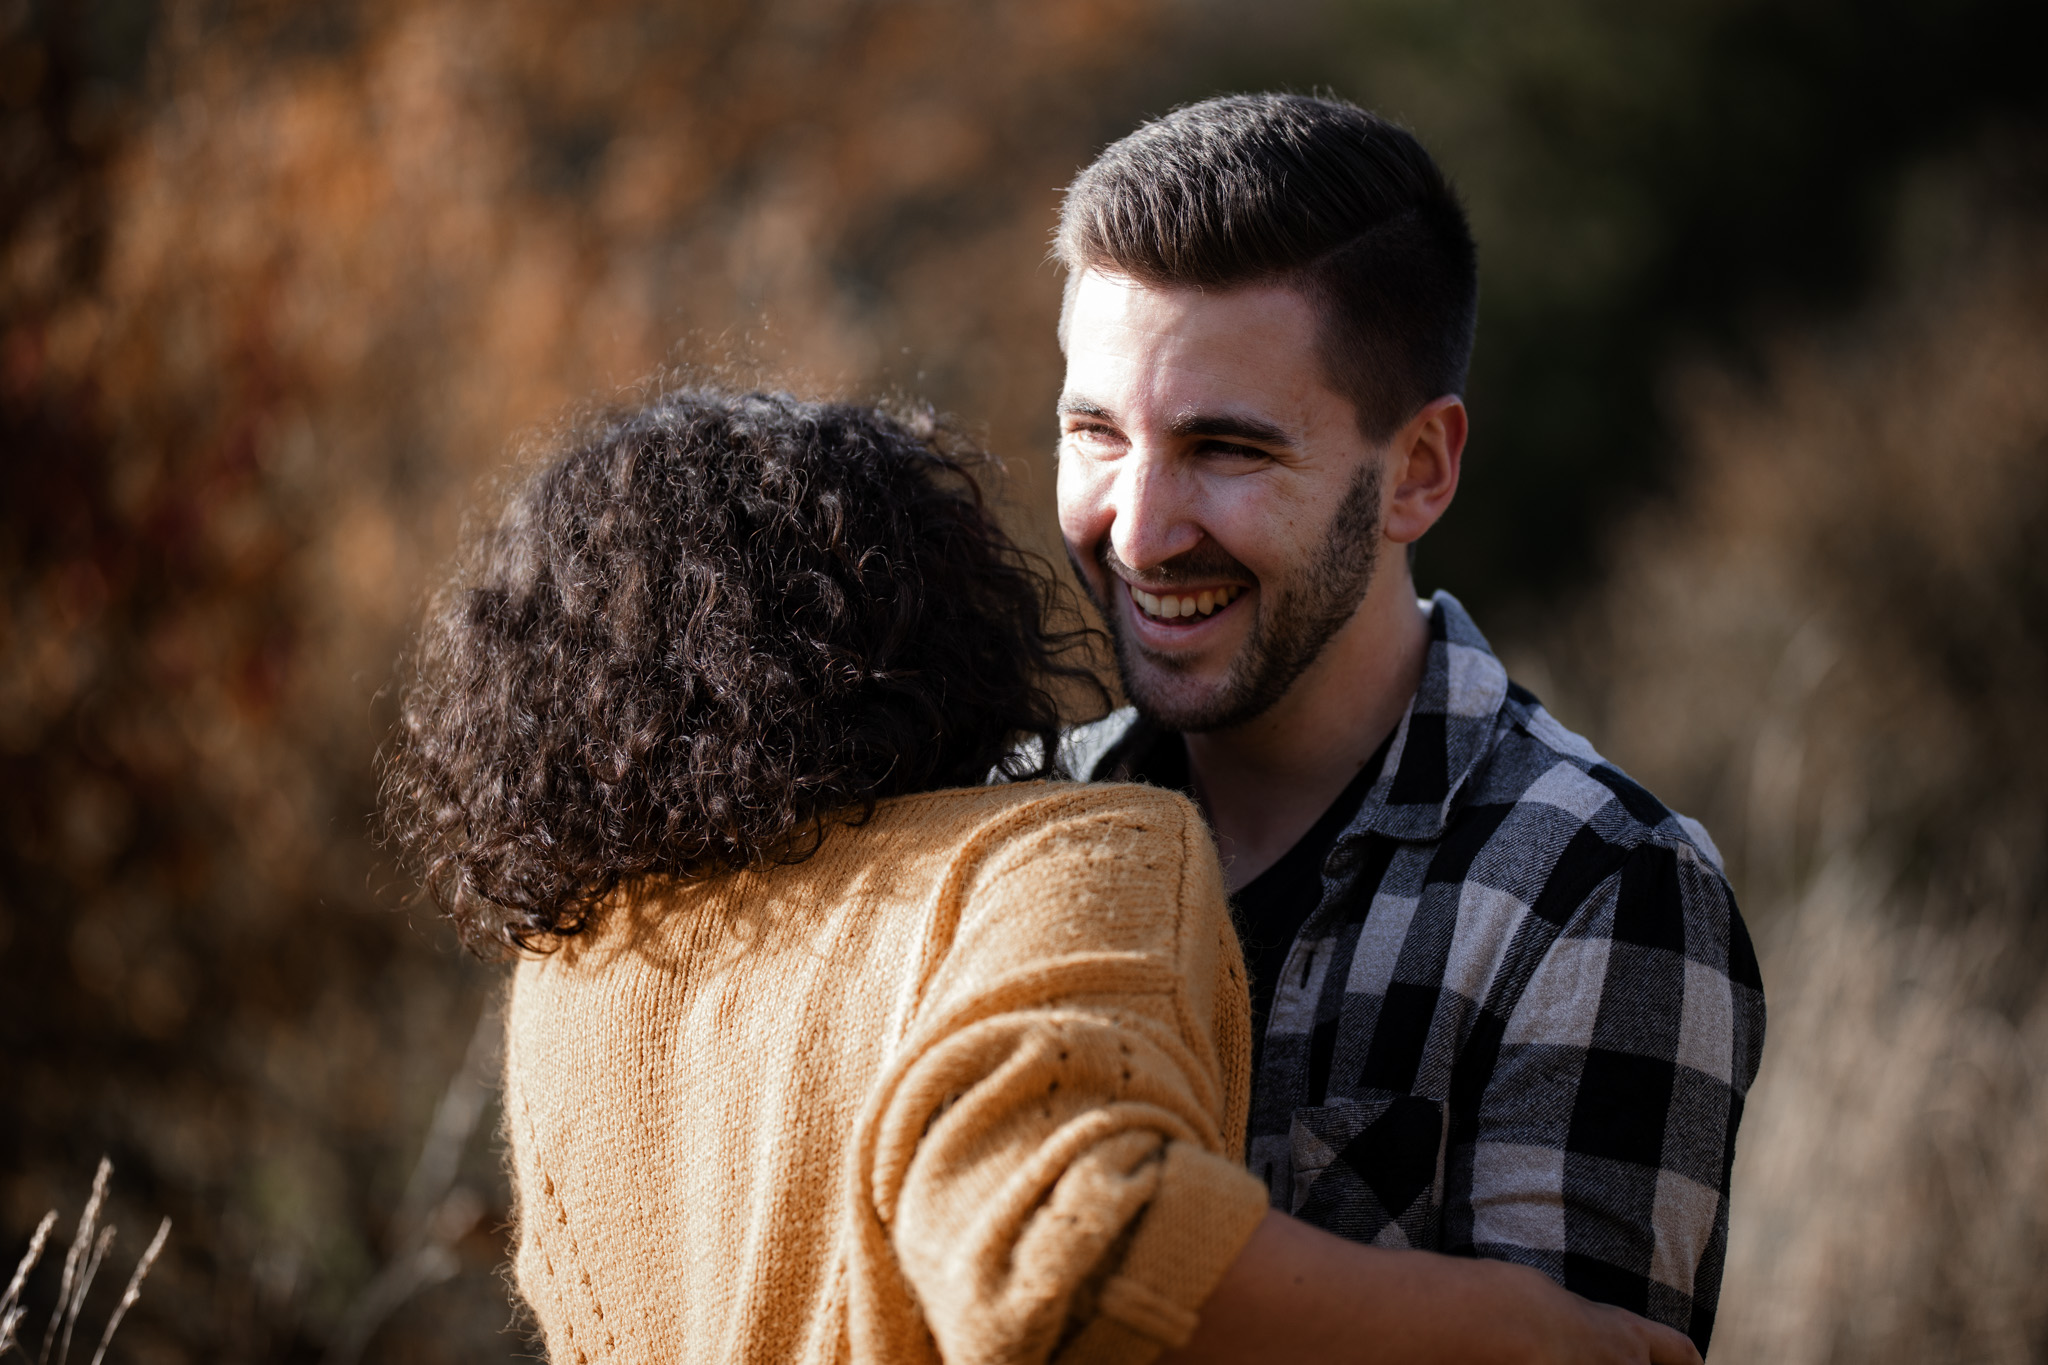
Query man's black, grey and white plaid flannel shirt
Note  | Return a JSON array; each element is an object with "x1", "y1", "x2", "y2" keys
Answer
[{"x1": 1065, "y1": 593, "x2": 1763, "y2": 1351}]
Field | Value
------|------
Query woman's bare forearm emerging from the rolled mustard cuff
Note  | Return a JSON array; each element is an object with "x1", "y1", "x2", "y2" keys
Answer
[{"x1": 1159, "y1": 1214, "x2": 1700, "y2": 1365}]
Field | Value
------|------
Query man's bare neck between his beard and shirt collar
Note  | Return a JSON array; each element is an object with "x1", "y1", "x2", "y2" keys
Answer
[{"x1": 1186, "y1": 573, "x2": 1430, "y2": 892}]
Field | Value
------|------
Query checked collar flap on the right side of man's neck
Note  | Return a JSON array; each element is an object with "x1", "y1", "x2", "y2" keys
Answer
[{"x1": 1346, "y1": 591, "x2": 1507, "y2": 839}]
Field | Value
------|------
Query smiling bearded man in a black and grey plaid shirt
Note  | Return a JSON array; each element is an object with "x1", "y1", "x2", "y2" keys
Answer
[{"x1": 1057, "y1": 96, "x2": 1763, "y2": 1351}]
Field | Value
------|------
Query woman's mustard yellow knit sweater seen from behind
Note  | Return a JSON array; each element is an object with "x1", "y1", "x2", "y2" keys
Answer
[{"x1": 506, "y1": 784, "x2": 1266, "y2": 1365}]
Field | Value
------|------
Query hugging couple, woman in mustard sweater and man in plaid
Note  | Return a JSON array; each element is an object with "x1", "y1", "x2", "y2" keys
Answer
[{"x1": 387, "y1": 96, "x2": 1763, "y2": 1365}]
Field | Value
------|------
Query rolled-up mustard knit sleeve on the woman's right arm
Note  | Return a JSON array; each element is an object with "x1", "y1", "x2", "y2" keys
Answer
[{"x1": 852, "y1": 788, "x2": 1266, "y2": 1361}]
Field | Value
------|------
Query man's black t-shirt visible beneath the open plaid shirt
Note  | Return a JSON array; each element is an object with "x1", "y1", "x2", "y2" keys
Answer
[{"x1": 1124, "y1": 731, "x2": 1393, "y2": 1070}]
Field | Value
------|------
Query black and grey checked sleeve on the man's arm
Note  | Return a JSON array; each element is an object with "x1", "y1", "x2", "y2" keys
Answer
[{"x1": 1446, "y1": 843, "x2": 1763, "y2": 1351}]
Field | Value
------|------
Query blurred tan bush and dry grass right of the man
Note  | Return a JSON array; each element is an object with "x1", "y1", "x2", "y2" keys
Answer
[{"x1": 1528, "y1": 196, "x2": 2048, "y2": 1365}]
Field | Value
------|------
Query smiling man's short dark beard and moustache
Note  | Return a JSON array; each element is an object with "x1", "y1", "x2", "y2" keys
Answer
[{"x1": 1081, "y1": 460, "x2": 1380, "y2": 733}]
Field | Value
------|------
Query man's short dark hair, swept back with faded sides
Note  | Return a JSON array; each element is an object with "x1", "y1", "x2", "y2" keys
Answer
[{"x1": 1053, "y1": 94, "x2": 1479, "y2": 440}]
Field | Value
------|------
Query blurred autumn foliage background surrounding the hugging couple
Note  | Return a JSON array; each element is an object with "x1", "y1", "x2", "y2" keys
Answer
[{"x1": 0, "y1": 0, "x2": 2048, "y2": 1365}]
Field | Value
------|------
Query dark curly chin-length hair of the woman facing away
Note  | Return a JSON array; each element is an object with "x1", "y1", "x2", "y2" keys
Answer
[{"x1": 383, "y1": 389, "x2": 1104, "y2": 952}]
